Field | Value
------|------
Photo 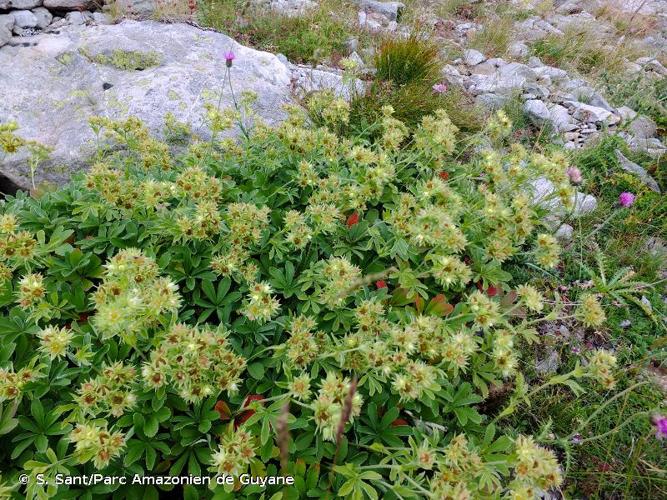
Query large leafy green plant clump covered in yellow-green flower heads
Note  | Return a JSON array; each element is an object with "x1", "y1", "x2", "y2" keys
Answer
[{"x1": 0, "y1": 97, "x2": 664, "y2": 499}]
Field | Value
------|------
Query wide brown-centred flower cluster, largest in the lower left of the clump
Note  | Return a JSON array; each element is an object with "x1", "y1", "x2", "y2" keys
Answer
[{"x1": 141, "y1": 324, "x2": 246, "y2": 403}]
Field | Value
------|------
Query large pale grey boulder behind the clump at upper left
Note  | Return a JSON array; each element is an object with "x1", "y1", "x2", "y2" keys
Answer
[{"x1": 0, "y1": 21, "x2": 290, "y2": 187}]
